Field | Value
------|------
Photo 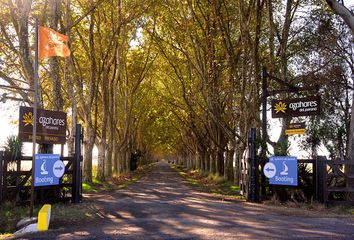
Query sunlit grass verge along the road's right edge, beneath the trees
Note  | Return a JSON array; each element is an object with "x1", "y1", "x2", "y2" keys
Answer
[{"x1": 172, "y1": 165, "x2": 243, "y2": 200}]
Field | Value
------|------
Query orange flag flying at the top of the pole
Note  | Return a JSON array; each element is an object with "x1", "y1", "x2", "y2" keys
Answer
[{"x1": 38, "y1": 26, "x2": 70, "y2": 59}]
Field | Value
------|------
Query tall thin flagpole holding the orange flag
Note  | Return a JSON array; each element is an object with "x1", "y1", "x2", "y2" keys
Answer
[{"x1": 30, "y1": 18, "x2": 39, "y2": 217}]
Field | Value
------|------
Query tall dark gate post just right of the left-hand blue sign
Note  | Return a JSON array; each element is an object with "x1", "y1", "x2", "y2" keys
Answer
[{"x1": 71, "y1": 124, "x2": 81, "y2": 203}]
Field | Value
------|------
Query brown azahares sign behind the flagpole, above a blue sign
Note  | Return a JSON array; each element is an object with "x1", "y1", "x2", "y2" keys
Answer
[{"x1": 19, "y1": 106, "x2": 67, "y2": 144}]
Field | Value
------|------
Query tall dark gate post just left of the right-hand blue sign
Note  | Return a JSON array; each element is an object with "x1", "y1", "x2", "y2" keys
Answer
[{"x1": 248, "y1": 128, "x2": 259, "y2": 202}]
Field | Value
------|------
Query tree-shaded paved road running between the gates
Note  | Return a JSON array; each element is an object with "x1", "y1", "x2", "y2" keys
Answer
[{"x1": 15, "y1": 162, "x2": 354, "y2": 239}]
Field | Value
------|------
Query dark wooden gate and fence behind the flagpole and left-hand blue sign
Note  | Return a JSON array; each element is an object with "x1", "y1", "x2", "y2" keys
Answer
[{"x1": 0, "y1": 124, "x2": 83, "y2": 203}]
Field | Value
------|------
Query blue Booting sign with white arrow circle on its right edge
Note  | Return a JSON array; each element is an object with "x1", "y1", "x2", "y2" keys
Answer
[{"x1": 34, "y1": 154, "x2": 65, "y2": 187}]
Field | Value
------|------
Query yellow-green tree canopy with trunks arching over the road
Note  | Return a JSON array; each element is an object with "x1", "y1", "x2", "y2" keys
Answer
[{"x1": 0, "y1": 0, "x2": 354, "y2": 183}]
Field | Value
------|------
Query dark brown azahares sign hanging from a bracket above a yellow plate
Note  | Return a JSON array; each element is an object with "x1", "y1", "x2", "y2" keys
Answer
[{"x1": 272, "y1": 96, "x2": 321, "y2": 118}]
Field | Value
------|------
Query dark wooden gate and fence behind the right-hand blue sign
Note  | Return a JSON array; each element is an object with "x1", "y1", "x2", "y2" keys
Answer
[{"x1": 240, "y1": 129, "x2": 354, "y2": 204}]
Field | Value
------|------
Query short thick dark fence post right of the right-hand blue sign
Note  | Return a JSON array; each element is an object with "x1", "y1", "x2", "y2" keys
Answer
[{"x1": 316, "y1": 156, "x2": 328, "y2": 203}]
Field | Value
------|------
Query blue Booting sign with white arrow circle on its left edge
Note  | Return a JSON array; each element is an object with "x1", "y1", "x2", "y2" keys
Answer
[{"x1": 263, "y1": 156, "x2": 298, "y2": 186}]
